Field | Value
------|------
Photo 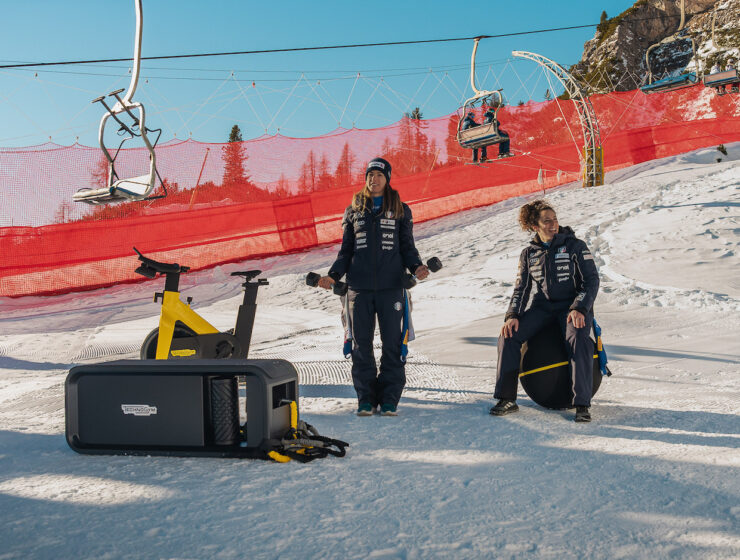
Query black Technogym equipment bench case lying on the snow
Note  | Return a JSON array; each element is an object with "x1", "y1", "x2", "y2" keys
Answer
[{"x1": 65, "y1": 359, "x2": 298, "y2": 457}]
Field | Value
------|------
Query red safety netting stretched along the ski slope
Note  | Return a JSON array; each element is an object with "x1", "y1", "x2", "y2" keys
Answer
[{"x1": 0, "y1": 85, "x2": 740, "y2": 296}]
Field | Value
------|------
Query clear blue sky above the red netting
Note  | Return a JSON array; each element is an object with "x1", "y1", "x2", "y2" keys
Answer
[{"x1": 0, "y1": 0, "x2": 632, "y2": 146}]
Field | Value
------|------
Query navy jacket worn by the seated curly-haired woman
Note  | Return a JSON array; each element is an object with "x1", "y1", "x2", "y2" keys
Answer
[{"x1": 506, "y1": 227, "x2": 599, "y2": 320}]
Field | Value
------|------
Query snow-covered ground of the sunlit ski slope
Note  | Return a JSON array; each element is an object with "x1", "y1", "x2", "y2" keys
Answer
[{"x1": 0, "y1": 144, "x2": 740, "y2": 559}]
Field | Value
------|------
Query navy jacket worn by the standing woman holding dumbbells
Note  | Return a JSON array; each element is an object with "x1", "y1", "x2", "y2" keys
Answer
[{"x1": 329, "y1": 204, "x2": 421, "y2": 290}]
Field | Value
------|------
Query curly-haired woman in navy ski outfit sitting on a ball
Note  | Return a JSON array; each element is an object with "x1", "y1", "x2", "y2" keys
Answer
[{"x1": 491, "y1": 200, "x2": 599, "y2": 422}]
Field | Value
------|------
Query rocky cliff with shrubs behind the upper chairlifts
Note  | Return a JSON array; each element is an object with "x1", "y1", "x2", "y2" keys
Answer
[{"x1": 570, "y1": 0, "x2": 740, "y2": 93}]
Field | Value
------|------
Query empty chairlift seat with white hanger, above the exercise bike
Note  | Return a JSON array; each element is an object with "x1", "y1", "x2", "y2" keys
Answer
[{"x1": 72, "y1": 0, "x2": 167, "y2": 205}]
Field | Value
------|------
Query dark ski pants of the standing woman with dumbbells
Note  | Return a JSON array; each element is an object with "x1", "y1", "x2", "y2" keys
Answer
[{"x1": 347, "y1": 289, "x2": 406, "y2": 406}]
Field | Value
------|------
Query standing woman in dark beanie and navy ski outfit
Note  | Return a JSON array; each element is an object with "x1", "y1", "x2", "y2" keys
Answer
[{"x1": 319, "y1": 158, "x2": 429, "y2": 416}]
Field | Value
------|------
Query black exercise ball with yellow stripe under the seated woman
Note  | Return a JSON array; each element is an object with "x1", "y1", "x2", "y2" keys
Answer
[{"x1": 519, "y1": 323, "x2": 602, "y2": 408}]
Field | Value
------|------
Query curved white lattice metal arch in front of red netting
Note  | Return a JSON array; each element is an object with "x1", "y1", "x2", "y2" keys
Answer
[{"x1": 511, "y1": 51, "x2": 604, "y2": 187}]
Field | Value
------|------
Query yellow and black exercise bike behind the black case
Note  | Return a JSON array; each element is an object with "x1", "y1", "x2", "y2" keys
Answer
[{"x1": 134, "y1": 247, "x2": 269, "y2": 360}]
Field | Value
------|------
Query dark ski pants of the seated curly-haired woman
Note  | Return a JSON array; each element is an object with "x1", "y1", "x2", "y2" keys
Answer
[{"x1": 493, "y1": 303, "x2": 594, "y2": 406}]
